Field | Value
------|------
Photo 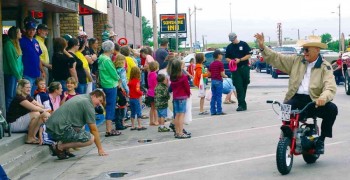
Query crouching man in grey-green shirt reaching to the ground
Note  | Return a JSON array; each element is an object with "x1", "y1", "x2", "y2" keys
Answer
[{"x1": 46, "y1": 90, "x2": 108, "y2": 159}]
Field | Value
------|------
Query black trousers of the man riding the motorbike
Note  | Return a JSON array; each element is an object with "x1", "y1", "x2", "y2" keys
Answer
[{"x1": 286, "y1": 94, "x2": 338, "y2": 138}]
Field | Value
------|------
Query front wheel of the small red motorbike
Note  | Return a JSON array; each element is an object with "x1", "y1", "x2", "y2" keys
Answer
[{"x1": 276, "y1": 137, "x2": 293, "y2": 175}]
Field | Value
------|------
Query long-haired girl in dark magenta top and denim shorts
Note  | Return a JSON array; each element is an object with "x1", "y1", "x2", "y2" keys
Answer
[{"x1": 170, "y1": 60, "x2": 191, "y2": 139}]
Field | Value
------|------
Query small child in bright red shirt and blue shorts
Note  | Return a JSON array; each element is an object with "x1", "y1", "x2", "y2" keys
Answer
[{"x1": 128, "y1": 66, "x2": 147, "y2": 131}]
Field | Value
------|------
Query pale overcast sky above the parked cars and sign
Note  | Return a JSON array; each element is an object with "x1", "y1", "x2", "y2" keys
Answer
[{"x1": 141, "y1": 0, "x2": 350, "y2": 43}]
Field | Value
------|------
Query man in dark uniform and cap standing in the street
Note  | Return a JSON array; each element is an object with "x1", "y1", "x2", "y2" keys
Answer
[{"x1": 225, "y1": 33, "x2": 251, "y2": 111}]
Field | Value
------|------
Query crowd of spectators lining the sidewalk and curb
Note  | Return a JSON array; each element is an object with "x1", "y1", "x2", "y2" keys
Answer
[{"x1": 3, "y1": 17, "x2": 246, "y2": 159}]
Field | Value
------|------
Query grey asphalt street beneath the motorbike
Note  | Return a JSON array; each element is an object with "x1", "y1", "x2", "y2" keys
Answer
[{"x1": 21, "y1": 71, "x2": 350, "y2": 180}]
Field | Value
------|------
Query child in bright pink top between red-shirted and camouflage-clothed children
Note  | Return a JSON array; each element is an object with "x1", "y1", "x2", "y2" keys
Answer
[{"x1": 147, "y1": 61, "x2": 159, "y2": 126}]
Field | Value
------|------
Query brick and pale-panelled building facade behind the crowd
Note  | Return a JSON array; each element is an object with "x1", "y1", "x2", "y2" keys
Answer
[{"x1": 0, "y1": 0, "x2": 142, "y2": 114}]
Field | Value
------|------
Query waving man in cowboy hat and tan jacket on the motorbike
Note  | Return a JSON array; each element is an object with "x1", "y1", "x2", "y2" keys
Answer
[{"x1": 254, "y1": 33, "x2": 338, "y2": 154}]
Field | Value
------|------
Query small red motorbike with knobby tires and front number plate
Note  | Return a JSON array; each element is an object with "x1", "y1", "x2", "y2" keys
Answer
[{"x1": 266, "y1": 100, "x2": 320, "y2": 175}]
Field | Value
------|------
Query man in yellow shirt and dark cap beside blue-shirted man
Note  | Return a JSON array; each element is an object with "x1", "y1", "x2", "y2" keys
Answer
[{"x1": 35, "y1": 24, "x2": 52, "y2": 85}]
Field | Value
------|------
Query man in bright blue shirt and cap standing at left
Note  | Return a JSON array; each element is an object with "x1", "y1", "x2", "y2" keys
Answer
[{"x1": 19, "y1": 21, "x2": 42, "y2": 96}]
